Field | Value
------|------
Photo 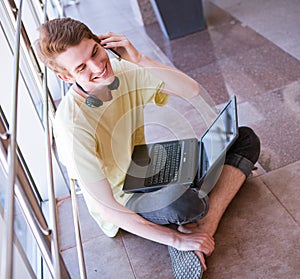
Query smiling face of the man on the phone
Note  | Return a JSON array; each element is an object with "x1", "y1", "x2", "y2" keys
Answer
[{"x1": 56, "y1": 38, "x2": 114, "y2": 92}]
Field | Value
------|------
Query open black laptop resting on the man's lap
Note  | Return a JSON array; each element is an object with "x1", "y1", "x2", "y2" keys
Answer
[{"x1": 123, "y1": 96, "x2": 238, "y2": 193}]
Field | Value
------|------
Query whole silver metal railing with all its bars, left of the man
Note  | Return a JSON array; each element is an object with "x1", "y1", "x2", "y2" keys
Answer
[{"x1": 1, "y1": 0, "x2": 86, "y2": 278}]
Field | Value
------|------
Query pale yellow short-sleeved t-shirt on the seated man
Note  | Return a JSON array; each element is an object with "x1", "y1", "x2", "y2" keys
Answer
[{"x1": 54, "y1": 60, "x2": 169, "y2": 237}]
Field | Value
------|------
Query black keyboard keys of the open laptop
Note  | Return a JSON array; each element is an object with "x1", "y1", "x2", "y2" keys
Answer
[{"x1": 145, "y1": 142, "x2": 181, "y2": 187}]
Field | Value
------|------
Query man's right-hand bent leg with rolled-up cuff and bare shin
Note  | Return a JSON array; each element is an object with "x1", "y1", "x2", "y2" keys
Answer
[{"x1": 178, "y1": 127, "x2": 260, "y2": 236}]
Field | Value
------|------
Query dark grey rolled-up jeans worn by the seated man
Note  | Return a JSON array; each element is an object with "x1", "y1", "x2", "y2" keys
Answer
[{"x1": 126, "y1": 127, "x2": 260, "y2": 228}]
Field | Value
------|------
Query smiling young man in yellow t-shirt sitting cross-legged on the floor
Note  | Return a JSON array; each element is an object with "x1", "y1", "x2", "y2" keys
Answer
[{"x1": 36, "y1": 18, "x2": 259, "y2": 278}]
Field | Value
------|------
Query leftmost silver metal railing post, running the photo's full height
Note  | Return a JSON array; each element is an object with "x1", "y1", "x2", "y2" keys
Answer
[{"x1": 1, "y1": 0, "x2": 23, "y2": 279}]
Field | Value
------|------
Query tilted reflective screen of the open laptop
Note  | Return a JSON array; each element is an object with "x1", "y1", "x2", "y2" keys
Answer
[{"x1": 200, "y1": 97, "x2": 238, "y2": 176}]
